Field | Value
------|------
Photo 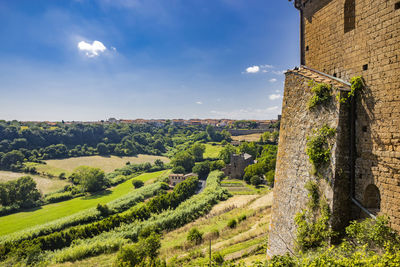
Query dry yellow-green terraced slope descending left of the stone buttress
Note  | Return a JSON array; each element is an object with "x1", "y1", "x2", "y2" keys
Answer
[{"x1": 51, "y1": 192, "x2": 272, "y2": 267}]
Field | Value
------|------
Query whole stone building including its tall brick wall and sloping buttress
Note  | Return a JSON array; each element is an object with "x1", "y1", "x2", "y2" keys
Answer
[{"x1": 268, "y1": 0, "x2": 400, "y2": 255}]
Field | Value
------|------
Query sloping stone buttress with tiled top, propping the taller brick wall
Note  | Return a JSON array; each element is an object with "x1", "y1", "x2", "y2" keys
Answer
[{"x1": 268, "y1": 69, "x2": 350, "y2": 255}]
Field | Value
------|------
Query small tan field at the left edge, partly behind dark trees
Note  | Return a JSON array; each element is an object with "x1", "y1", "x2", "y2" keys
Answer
[{"x1": 0, "y1": 171, "x2": 70, "y2": 194}]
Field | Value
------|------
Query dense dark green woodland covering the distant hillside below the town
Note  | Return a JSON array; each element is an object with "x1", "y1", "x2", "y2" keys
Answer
[{"x1": 0, "y1": 121, "x2": 230, "y2": 173}]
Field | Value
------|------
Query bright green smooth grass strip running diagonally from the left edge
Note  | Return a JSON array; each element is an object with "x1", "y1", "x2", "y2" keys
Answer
[{"x1": 0, "y1": 171, "x2": 165, "y2": 235}]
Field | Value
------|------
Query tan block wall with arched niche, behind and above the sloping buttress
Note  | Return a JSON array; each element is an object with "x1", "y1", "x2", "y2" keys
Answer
[{"x1": 304, "y1": 0, "x2": 400, "y2": 231}]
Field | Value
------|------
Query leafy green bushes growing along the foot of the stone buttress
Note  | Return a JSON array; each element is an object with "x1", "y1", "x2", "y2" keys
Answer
[{"x1": 266, "y1": 217, "x2": 400, "y2": 267}]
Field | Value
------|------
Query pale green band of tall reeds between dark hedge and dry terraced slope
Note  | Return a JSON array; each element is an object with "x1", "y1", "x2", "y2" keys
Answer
[{"x1": 47, "y1": 171, "x2": 229, "y2": 262}]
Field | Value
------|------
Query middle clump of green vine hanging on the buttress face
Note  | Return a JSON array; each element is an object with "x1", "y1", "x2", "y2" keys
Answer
[{"x1": 306, "y1": 125, "x2": 336, "y2": 174}]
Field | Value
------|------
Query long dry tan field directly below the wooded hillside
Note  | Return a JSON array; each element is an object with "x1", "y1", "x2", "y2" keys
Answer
[{"x1": 26, "y1": 155, "x2": 170, "y2": 176}]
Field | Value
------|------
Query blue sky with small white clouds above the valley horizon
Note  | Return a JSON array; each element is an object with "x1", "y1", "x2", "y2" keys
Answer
[{"x1": 0, "y1": 0, "x2": 299, "y2": 121}]
